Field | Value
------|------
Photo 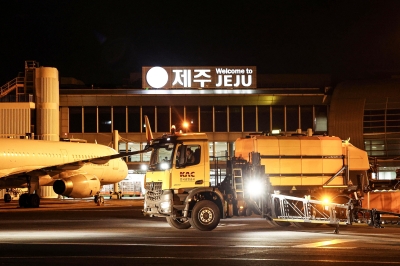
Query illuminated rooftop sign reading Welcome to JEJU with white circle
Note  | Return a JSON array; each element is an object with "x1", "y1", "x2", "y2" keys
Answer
[{"x1": 142, "y1": 66, "x2": 257, "y2": 89}]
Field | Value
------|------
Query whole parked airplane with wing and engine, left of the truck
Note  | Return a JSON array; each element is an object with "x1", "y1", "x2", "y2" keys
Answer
[{"x1": 0, "y1": 138, "x2": 146, "y2": 208}]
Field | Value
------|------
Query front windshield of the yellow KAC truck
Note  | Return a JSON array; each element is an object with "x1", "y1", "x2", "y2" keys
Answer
[{"x1": 149, "y1": 143, "x2": 174, "y2": 170}]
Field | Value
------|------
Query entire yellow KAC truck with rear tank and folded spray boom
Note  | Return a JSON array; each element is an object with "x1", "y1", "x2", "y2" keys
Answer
[{"x1": 143, "y1": 120, "x2": 398, "y2": 231}]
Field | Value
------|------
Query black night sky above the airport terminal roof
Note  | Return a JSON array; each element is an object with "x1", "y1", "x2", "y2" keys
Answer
[{"x1": 0, "y1": 0, "x2": 400, "y2": 86}]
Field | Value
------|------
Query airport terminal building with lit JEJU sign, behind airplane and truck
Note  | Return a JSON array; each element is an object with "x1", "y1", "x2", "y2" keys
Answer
[{"x1": 0, "y1": 61, "x2": 400, "y2": 196}]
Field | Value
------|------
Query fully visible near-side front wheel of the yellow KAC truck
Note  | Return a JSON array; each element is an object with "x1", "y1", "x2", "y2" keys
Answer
[{"x1": 189, "y1": 200, "x2": 220, "y2": 231}]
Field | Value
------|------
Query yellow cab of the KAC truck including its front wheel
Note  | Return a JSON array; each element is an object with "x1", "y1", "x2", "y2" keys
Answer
[{"x1": 143, "y1": 132, "x2": 224, "y2": 230}]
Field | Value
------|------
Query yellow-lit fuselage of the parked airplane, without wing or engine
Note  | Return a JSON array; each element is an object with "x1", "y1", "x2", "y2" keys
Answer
[{"x1": 0, "y1": 138, "x2": 128, "y2": 188}]
